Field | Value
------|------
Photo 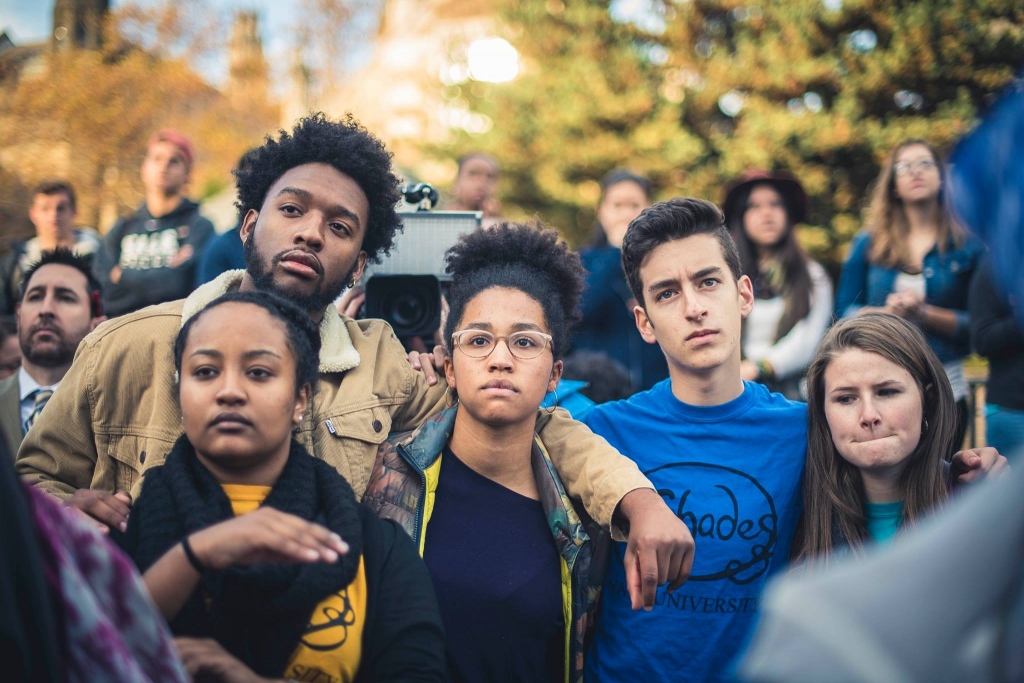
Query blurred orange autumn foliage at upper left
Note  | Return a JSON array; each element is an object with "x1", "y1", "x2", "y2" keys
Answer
[{"x1": 0, "y1": 2, "x2": 279, "y2": 228}]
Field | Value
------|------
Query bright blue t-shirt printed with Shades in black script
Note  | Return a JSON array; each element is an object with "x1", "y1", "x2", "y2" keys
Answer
[{"x1": 586, "y1": 380, "x2": 807, "y2": 683}]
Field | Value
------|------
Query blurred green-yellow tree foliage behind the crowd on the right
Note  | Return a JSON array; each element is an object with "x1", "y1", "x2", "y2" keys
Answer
[{"x1": 434, "y1": 0, "x2": 1024, "y2": 262}]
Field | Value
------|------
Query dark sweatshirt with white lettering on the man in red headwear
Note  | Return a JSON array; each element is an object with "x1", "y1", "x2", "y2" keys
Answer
[{"x1": 94, "y1": 200, "x2": 214, "y2": 317}]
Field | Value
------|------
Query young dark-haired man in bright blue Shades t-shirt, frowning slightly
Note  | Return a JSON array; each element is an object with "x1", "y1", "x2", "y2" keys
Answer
[{"x1": 585, "y1": 194, "x2": 807, "y2": 683}]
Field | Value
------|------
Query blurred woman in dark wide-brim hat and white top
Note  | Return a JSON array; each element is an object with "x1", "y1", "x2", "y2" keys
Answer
[{"x1": 723, "y1": 170, "x2": 833, "y2": 398}]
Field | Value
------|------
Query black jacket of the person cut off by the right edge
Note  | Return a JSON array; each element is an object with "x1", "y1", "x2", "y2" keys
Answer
[{"x1": 968, "y1": 259, "x2": 1024, "y2": 411}]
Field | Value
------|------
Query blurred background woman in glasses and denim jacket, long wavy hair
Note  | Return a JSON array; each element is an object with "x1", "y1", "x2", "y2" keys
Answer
[{"x1": 836, "y1": 140, "x2": 983, "y2": 443}]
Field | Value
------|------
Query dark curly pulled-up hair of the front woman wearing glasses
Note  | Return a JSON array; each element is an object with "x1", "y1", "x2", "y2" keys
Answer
[{"x1": 444, "y1": 222, "x2": 586, "y2": 359}]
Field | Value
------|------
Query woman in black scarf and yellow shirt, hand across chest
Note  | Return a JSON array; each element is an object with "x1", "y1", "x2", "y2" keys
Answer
[{"x1": 120, "y1": 293, "x2": 444, "y2": 681}]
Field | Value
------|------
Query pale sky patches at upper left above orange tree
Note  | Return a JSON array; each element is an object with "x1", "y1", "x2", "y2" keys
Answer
[{"x1": 0, "y1": 0, "x2": 364, "y2": 84}]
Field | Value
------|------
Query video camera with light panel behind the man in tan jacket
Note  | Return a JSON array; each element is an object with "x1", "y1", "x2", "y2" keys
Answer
[{"x1": 362, "y1": 182, "x2": 483, "y2": 340}]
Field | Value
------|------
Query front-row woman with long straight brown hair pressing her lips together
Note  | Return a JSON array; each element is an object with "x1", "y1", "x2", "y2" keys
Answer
[{"x1": 795, "y1": 312, "x2": 1006, "y2": 559}]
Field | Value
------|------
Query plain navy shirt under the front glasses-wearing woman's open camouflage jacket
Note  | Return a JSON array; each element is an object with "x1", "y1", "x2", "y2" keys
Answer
[{"x1": 423, "y1": 447, "x2": 565, "y2": 683}]
